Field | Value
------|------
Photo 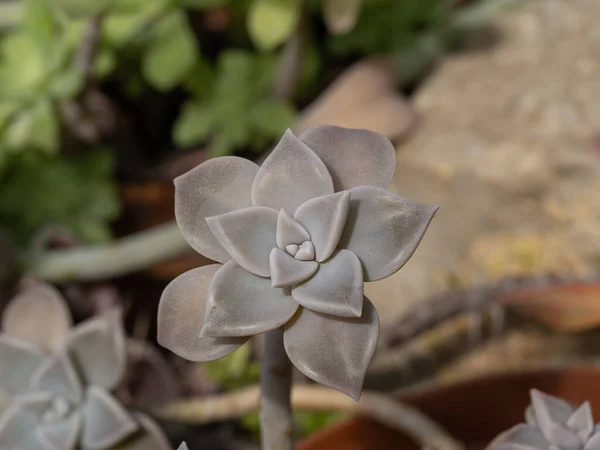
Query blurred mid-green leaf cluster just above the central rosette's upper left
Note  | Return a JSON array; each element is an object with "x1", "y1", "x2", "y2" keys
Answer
[{"x1": 174, "y1": 50, "x2": 295, "y2": 156}]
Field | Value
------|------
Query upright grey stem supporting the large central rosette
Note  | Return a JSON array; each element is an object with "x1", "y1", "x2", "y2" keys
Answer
[{"x1": 260, "y1": 328, "x2": 292, "y2": 450}]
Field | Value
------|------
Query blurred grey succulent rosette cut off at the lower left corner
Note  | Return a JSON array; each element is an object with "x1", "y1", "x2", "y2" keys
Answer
[{"x1": 0, "y1": 284, "x2": 170, "y2": 450}]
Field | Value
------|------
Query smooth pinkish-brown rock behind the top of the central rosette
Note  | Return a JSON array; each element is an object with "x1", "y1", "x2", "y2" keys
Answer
[{"x1": 294, "y1": 59, "x2": 416, "y2": 140}]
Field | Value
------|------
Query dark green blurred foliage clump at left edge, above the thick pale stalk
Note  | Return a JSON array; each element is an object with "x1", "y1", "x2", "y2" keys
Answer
[{"x1": 0, "y1": 151, "x2": 119, "y2": 245}]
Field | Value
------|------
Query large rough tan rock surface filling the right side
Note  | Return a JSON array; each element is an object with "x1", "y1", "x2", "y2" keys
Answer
[{"x1": 366, "y1": 0, "x2": 600, "y2": 325}]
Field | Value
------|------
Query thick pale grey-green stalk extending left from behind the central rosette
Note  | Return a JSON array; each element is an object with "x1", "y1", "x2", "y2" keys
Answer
[{"x1": 26, "y1": 222, "x2": 190, "y2": 283}]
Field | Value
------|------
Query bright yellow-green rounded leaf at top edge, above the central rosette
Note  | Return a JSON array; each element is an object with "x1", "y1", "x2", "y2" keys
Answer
[{"x1": 248, "y1": 0, "x2": 300, "y2": 51}]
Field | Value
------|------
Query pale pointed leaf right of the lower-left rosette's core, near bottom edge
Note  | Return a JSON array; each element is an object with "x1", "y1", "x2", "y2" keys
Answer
[{"x1": 81, "y1": 386, "x2": 138, "y2": 450}]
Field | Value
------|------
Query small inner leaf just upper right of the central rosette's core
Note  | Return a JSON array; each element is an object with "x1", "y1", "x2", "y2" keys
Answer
[{"x1": 294, "y1": 191, "x2": 350, "y2": 262}]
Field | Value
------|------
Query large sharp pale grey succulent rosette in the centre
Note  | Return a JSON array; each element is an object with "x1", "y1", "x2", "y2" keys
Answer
[{"x1": 158, "y1": 126, "x2": 437, "y2": 399}]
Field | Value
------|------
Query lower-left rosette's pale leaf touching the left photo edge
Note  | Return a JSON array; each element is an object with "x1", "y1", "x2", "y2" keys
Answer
[{"x1": 0, "y1": 334, "x2": 44, "y2": 397}]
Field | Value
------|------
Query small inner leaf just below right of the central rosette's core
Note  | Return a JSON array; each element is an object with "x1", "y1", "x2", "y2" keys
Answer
[{"x1": 292, "y1": 250, "x2": 364, "y2": 317}]
